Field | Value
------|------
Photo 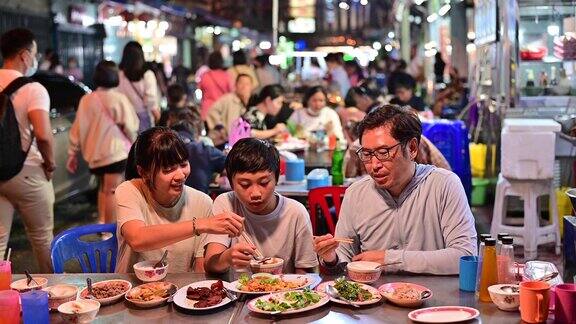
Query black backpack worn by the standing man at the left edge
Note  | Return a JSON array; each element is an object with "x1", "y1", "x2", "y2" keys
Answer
[{"x1": 0, "y1": 77, "x2": 34, "y2": 181}]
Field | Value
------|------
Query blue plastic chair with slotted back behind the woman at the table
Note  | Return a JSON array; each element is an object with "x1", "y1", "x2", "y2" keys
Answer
[{"x1": 51, "y1": 224, "x2": 118, "y2": 273}]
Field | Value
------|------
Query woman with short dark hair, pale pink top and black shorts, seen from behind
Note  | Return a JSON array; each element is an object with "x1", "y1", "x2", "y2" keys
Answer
[{"x1": 66, "y1": 61, "x2": 138, "y2": 223}]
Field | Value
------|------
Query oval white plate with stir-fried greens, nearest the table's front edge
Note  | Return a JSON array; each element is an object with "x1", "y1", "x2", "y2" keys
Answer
[{"x1": 248, "y1": 288, "x2": 330, "y2": 315}]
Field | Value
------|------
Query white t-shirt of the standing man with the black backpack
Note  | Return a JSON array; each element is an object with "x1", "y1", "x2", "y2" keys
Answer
[{"x1": 0, "y1": 69, "x2": 50, "y2": 166}]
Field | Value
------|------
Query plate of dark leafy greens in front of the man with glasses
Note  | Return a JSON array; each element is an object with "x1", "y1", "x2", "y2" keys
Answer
[{"x1": 316, "y1": 277, "x2": 382, "y2": 306}]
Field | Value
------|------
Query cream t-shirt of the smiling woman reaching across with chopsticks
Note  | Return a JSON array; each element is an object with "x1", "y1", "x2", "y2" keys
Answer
[{"x1": 115, "y1": 179, "x2": 212, "y2": 273}]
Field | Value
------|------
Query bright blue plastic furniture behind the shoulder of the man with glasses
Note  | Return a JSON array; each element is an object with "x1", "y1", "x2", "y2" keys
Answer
[{"x1": 422, "y1": 119, "x2": 472, "y2": 201}]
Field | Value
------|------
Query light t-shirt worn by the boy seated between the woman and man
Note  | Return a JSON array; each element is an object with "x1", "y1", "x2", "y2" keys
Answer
[{"x1": 204, "y1": 191, "x2": 318, "y2": 273}]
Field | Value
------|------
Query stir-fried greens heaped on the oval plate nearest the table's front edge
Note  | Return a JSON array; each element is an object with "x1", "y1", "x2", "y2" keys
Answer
[{"x1": 255, "y1": 288, "x2": 322, "y2": 312}]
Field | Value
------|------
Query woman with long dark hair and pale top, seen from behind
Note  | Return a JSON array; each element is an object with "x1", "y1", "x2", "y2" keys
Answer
[{"x1": 118, "y1": 41, "x2": 160, "y2": 133}]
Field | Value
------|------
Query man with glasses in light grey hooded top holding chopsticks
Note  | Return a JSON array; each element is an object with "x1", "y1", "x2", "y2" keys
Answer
[{"x1": 314, "y1": 105, "x2": 476, "y2": 274}]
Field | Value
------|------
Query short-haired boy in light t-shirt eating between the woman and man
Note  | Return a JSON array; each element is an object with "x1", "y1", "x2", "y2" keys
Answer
[{"x1": 204, "y1": 138, "x2": 318, "y2": 273}]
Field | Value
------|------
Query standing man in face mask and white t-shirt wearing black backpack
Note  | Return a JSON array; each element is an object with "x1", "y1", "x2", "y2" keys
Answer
[{"x1": 0, "y1": 28, "x2": 56, "y2": 273}]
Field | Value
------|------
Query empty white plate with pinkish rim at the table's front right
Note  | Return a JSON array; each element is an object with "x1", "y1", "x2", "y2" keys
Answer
[{"x1": 408, "y1": 306, "x2": 480, "y2": 323}]
